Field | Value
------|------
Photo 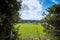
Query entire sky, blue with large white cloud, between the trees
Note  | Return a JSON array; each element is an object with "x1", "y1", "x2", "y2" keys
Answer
[{"x1": 19, "y1": 0, "x2": 60, "y2": 20}]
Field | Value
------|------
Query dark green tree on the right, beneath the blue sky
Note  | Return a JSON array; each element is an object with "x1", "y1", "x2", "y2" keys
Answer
[{"x1": 46, "y1": 4, "x2": 60, "y2": 40}]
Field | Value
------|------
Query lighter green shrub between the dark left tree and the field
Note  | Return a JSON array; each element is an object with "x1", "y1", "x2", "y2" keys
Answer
[{"x1": 11, "y1": 23, "x2": 21, "y2": 40}]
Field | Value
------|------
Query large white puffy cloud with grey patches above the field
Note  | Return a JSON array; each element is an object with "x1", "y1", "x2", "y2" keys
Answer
[{"x1": 20, "y1": 0, "x2": 43, "y2": 20}]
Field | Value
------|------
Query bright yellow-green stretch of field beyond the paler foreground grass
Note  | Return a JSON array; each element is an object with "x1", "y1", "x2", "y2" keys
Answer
[{"x1": 16, "y1": 23, "x2": 45, "y2": 35}]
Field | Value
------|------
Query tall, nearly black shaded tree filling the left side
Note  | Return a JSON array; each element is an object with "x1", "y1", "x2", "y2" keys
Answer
[{"x1": 0, "y1": 0, "x2": 21, "y2": 40}]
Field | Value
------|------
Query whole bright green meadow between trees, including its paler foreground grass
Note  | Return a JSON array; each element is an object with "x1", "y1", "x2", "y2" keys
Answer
[{"x1": 15, "y1": 23, "x2": 45, "y2": 40}]
